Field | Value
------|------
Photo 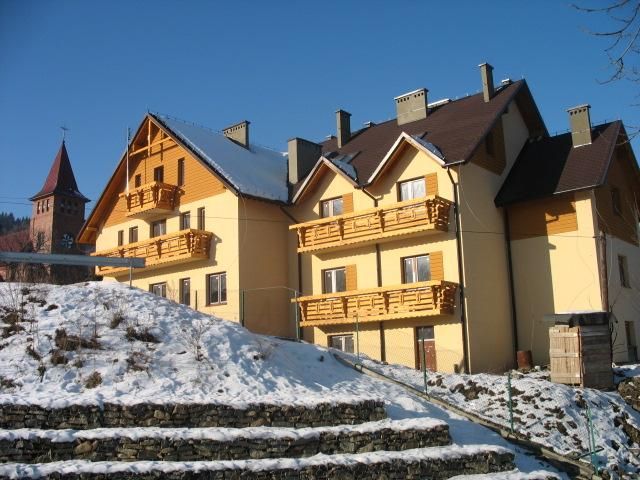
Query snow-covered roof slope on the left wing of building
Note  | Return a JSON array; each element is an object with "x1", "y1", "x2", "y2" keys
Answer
[{"x1": 151, "y1": 114, "x2": 288, "y2": 202}]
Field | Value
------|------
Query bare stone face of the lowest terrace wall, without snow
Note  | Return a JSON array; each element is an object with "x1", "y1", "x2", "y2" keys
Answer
[{"x1": 0, "y1": 452, "x2": 515, "y2": 480}]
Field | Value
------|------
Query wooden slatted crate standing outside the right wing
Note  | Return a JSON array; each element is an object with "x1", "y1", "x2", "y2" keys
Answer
[{"x1": 549, "y1": 325, "x2": 613, "y2": 389}]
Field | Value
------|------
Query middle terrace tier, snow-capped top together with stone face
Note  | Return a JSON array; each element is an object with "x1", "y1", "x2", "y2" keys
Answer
[{"x1": 0, "y1": 418, "x2": 451, "y2": 463}]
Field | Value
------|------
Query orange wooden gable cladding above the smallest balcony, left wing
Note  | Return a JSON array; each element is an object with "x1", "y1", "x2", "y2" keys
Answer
[{"x1": 101, "y1": 119, "x2": 226, "y2": 227}]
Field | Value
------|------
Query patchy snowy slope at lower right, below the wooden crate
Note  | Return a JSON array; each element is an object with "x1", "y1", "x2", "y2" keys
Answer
[{"x1": 351, "y1": 357, "x2": 640, "y2": 474}]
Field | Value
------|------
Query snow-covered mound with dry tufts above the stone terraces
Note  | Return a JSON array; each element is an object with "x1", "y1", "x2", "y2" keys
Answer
[{"x1": 0, "y1": 282, "x2": 555, "y2": 472}]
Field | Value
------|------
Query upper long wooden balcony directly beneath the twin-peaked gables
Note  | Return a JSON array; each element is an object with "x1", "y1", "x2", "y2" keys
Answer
[{"x1": 289, "y1": 196, "x2": 452, "y2": 253}]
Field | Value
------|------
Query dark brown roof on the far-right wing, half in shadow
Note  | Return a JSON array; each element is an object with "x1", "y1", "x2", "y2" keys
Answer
[{"x1": 495, "y1": 120, "x2": 624, "y2": 207}]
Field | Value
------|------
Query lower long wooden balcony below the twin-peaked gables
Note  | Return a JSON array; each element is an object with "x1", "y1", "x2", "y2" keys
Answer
[{"x1": 293, "y1": 280, "x2": 458, "y2": 327}]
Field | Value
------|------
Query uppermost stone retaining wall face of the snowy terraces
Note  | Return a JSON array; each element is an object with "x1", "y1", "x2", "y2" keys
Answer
[{"x1": 0, "y1": 400, "x2": 387, "y2": 430}]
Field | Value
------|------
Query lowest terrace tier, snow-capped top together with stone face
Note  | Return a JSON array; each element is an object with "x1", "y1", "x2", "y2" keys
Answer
[{"x1": 0, "y1": 445, "x2": 515, "y2": 480}]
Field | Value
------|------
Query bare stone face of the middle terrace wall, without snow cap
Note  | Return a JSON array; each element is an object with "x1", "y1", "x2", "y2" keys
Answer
[{"x1": 0, "y1": 425, "x2": 451, "y2": 463}]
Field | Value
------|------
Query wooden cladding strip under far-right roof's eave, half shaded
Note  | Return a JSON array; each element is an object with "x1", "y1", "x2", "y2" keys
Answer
[{"x1": 508, "y1": 194, "x2": 578, "y2": 240}]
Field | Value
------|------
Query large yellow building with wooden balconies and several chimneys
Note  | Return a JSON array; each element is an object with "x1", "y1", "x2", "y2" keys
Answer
[{"x1": 79, "y1": 64, "x2": 640, "y2": 372}]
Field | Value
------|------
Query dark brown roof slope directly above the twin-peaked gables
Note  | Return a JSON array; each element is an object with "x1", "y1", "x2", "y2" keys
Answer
[{"x1": 322, "y1": 80, "x2": 541, "y2": 184}]
